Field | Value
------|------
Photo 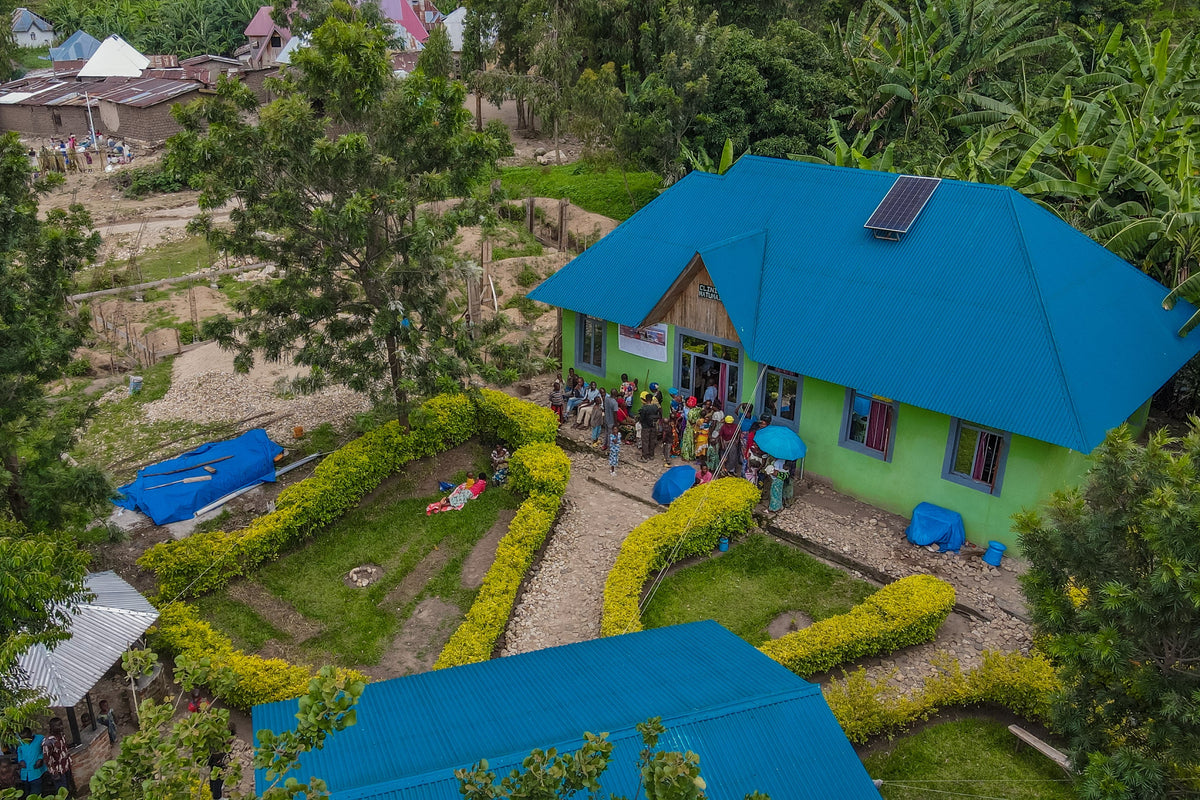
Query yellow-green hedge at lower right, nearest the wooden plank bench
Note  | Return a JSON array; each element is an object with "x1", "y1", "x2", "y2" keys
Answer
[{"x1": 824, "y1": 650, "x2": 1060, "y2": 745}]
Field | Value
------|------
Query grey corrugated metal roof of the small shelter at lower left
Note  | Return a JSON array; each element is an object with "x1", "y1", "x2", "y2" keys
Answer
[{"x1": 17, "y1": 572, "x2": 158, "y2": 708}]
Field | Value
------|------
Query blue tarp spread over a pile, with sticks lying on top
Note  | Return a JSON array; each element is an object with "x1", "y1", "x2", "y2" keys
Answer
[{"x1": 113, "y1": 428, "x2": 283, "y2": 525}]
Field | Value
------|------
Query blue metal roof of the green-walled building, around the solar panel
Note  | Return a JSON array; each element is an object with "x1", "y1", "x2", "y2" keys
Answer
[{"x1": 529, "y1": 156, "x2": 1200, "y2": 452}]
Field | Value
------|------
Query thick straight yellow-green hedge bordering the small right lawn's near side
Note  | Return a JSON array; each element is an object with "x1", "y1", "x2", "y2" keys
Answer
[{"x1": 758, "y1": 575, "x2": 954, "y2": 678}]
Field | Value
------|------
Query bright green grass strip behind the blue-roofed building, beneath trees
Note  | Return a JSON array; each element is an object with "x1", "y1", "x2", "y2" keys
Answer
[{"x1": 500, "y1": 161, "x2": 662, "y2": 219}]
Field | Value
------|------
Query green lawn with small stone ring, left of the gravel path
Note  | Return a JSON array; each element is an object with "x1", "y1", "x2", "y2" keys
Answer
[{"x1": 198, "y1": 462, "x2": 518, "y2": 666}]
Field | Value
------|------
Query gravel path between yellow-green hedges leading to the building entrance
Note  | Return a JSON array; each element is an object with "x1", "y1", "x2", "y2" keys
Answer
[{"x1": 502, "y1": 453, "x2": 654, "y2": 656}]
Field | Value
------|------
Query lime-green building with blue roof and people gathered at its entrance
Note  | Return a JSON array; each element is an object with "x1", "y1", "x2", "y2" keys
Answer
[{"x1": 529, "y1": 156, "x2": 1200, "y2": 546}]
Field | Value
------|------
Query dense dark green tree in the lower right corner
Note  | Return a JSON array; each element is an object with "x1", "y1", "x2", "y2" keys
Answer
[{"x1": 1016, "y1": 422, "x2": 1200, "y2": 800}]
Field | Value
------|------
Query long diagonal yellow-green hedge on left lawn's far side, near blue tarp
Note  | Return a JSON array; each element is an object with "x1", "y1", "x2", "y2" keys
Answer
[{"x1": 138, "y1": 390, "x2": 506, "y2": 599}]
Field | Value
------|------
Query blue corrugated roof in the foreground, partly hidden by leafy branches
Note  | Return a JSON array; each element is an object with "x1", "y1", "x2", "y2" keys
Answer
[{"x1": 253, "y1": 621, "x2": 880, "y2": 800}]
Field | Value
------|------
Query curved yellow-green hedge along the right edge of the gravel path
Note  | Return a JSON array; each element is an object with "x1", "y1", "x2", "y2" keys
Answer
[{"x1": 600, "y1": 477, "x2": 762, "y2": 636}]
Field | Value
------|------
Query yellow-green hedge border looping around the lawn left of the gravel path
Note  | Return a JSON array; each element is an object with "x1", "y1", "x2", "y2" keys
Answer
[{"x1": 145, "y1": 389, "x2": 570, "y2": 710}]
